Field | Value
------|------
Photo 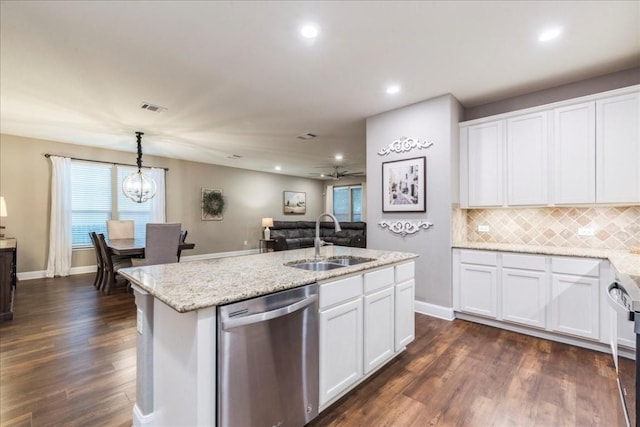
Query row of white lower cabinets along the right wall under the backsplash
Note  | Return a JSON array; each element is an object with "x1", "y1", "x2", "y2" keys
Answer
[{"x1": 453, "y1": 249, "x2": 610, "y2": 348}]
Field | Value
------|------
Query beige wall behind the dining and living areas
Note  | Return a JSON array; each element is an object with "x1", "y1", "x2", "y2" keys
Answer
[{"x1": 0, "y1": 134, "x2": 325, "y2": 272}]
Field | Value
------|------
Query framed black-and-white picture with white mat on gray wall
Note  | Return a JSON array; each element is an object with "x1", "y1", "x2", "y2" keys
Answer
[{"x1": 382, "y1": 157, "x2": 427, "y2": 212}]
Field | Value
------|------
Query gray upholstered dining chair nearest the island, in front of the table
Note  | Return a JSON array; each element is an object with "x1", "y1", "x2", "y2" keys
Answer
[{"x1": 132, "y1": 223, "x2": 181, "y2": 266}]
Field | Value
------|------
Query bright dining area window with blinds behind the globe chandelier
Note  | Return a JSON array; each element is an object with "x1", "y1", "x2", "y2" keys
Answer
[{"x1": 71, "y1": 160, "x2": 154, "y2": 248}]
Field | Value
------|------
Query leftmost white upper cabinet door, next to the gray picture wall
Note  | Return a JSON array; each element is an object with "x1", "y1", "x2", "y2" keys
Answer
[{"x1": 467, "y1": 121, "x2": 504, "y2": 206}]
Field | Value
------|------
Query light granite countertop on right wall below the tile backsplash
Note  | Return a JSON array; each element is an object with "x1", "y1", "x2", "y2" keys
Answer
[{"x1": 452, "y1": 242, "x2": 640, "y2": 288}]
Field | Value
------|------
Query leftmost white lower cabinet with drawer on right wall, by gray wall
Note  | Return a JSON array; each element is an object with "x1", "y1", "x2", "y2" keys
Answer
[{"x1": 458, "y1": 251, "x2": 498, "y2": 318}]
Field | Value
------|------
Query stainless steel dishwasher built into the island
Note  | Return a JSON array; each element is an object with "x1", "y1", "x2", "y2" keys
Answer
[{"x1": 217, "y1": 284, "x2": 319, "y2": 427}]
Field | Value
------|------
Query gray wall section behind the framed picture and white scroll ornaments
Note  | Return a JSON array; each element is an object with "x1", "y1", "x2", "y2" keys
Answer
[{"x1": 367, "y1": 95, "x2": 462, "y2": 307}]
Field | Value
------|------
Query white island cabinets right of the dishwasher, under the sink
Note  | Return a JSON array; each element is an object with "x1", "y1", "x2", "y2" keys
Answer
[{"x1": 319, "y1": 262, "x2": 415, "y2": 408}]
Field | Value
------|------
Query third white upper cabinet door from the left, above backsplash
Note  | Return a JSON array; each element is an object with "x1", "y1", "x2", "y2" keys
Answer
[{"x1": 553, "y1": 102, "x2": 596, "y2": 205}]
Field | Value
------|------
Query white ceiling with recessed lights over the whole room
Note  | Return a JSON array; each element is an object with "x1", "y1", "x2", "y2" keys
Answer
[{"x1": 0, "y1": 1, "x2": 640, "y2": 176}]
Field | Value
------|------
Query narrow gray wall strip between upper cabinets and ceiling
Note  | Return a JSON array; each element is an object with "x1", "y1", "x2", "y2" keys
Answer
[{"x1": 464, "y1": 67, "x2": 640, "y2": 120}]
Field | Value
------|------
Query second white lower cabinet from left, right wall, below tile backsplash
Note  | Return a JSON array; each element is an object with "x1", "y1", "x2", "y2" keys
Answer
[{"x1": 501, "y1": 254, "x2": 547, "y2": 329}]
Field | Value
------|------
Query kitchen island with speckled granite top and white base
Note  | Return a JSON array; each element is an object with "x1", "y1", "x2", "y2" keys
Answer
[{"x1": 120, "y1": 246, "x2": 417, "y2": 426}]
